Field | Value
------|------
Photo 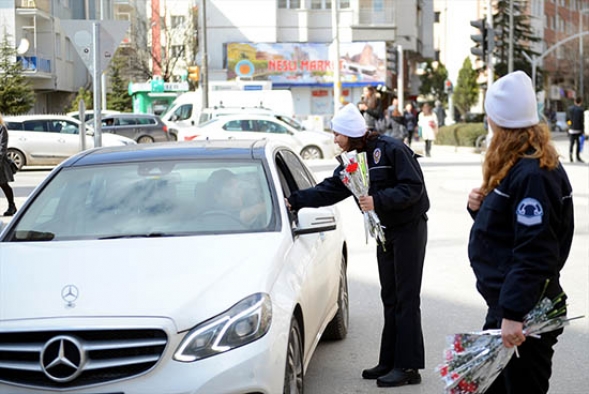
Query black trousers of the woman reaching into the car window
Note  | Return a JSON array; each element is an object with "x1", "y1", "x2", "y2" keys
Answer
[{"x1": 376, "y1": 214, "x2": 427, "y2": 369}]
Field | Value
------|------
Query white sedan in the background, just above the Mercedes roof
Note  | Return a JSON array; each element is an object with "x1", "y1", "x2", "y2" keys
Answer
[{"x1": 179, "y1": 114, "x2": 337, "y2": 159}]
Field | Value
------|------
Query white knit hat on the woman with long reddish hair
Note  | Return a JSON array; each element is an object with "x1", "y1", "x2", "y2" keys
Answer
[{"x1": 485, "y1": 71, "x2": 540, "y2": 129}]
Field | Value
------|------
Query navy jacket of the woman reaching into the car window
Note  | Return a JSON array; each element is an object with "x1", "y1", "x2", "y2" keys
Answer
[{"x1": 288, "y1": 135, "x2": 429, "y2": 230}]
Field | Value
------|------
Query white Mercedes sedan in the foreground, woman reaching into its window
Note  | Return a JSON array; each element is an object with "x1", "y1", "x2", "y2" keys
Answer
[{"x1": 0, "y1": 140, "x2": 348, "y2": 394}]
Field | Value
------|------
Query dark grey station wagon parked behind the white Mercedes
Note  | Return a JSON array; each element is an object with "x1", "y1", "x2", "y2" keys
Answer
[{"x1": 94, "y1": 114, "x2": 174, "y2": 144}]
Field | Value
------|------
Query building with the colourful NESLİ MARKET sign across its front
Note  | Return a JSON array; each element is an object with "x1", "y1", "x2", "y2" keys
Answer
[{"x1": 201, "y1": 0, "x2": 434, "y2": 117}]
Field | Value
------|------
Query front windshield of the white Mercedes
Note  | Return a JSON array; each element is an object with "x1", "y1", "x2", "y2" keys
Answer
[{"x1": 6, "y1": 159, "x2": 276, "y2": 242}]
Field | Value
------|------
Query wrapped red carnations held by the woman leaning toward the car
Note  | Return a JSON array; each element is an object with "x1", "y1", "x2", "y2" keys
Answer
[{"x1": 338, "y1": 150, "x2": 385, "y2": 248}]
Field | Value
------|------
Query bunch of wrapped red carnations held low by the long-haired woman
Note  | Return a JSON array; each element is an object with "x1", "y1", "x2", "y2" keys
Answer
[{"x1": 436, "y1": 295, "x2": 582, "y2": 394}]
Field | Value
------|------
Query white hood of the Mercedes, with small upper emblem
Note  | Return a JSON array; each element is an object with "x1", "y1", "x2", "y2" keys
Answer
[{"x1": 0, "y1": 232, "x2": 287, "y2": 331}]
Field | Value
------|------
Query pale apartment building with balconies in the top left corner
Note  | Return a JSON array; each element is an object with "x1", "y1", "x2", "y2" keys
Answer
[{"x1": 0, "y1": 0, "x2": 114, "y2": 113}]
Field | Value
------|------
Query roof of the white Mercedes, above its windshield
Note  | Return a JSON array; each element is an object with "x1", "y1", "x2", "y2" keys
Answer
[{"x1": 61, "y1": 139, "x2": 292, "y2": 167}]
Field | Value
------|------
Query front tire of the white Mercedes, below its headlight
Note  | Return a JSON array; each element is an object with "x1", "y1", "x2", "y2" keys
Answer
[{"x1": 283, "y1": 316, "x2": 304, "y2": 394}]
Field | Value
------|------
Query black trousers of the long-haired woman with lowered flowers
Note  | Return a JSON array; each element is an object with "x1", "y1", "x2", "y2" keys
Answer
[{"x1": 484, "y1": 315, "x2": 563, "y2": 394}]
